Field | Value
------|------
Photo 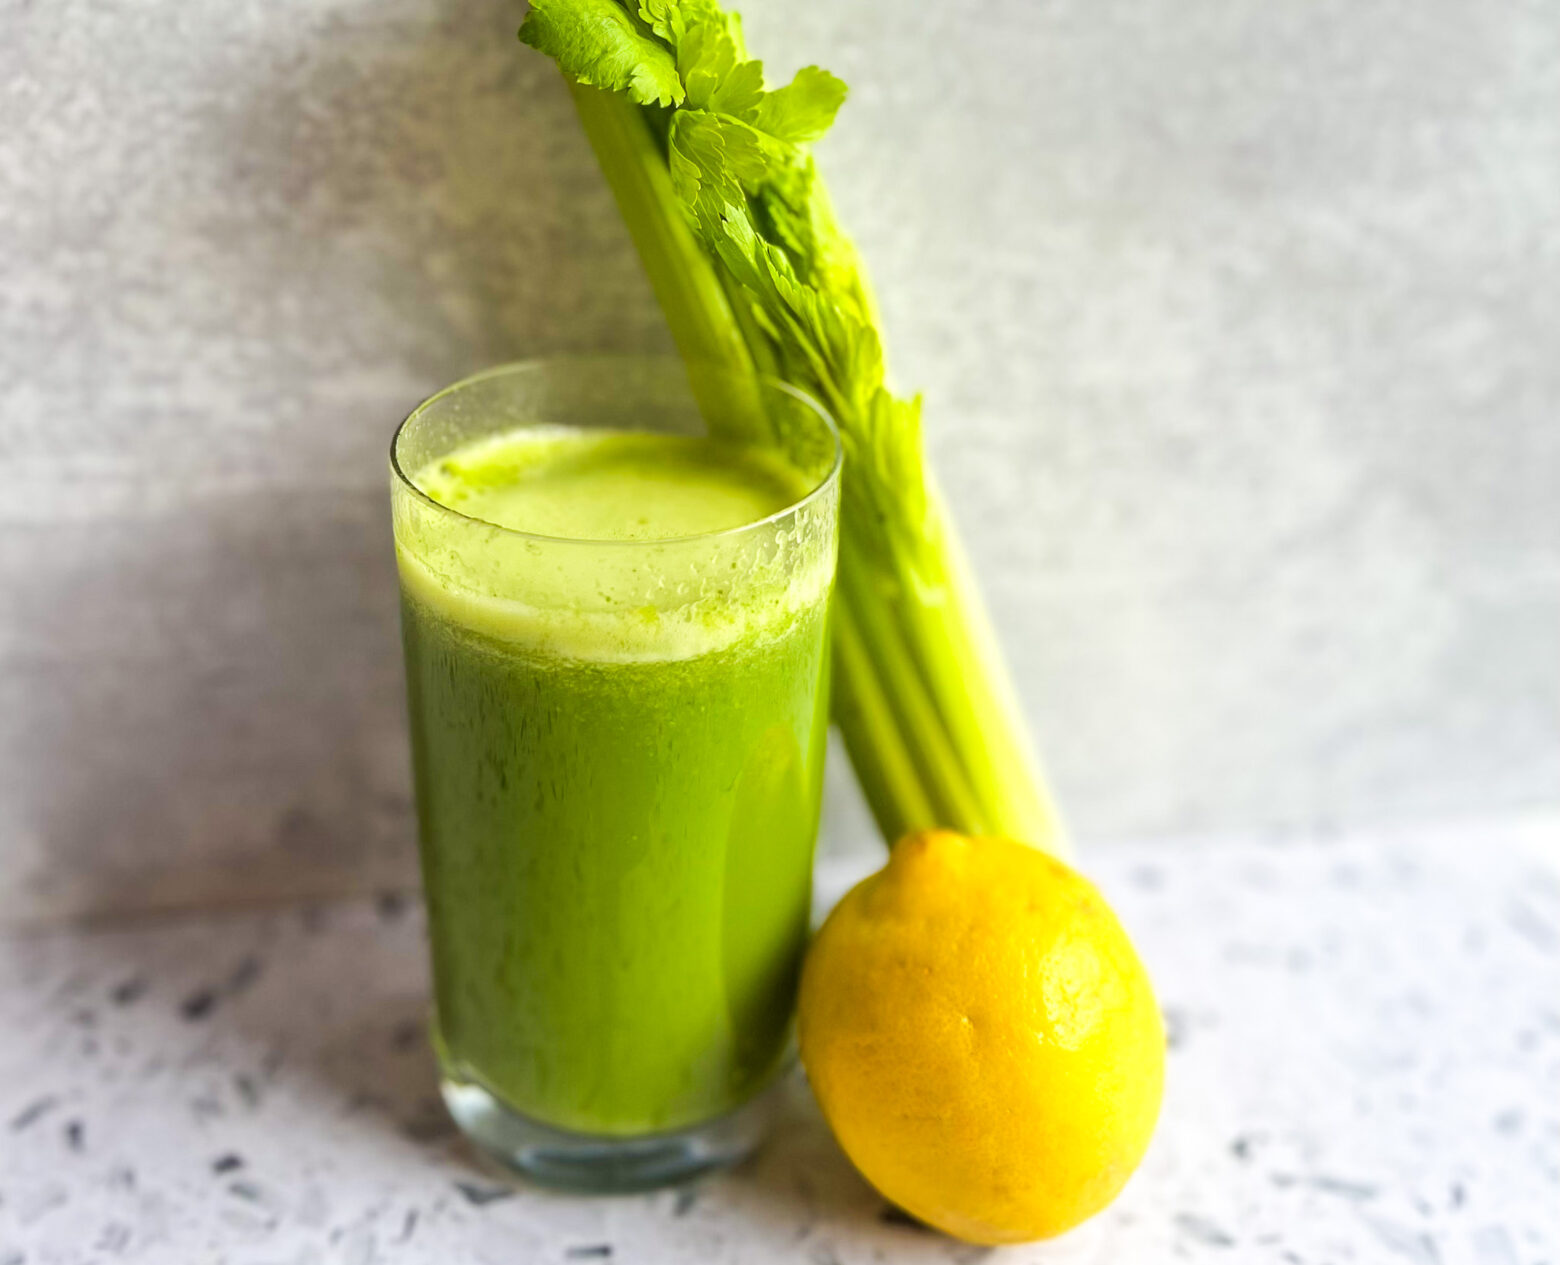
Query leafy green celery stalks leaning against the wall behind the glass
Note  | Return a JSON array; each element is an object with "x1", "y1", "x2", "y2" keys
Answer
[{"x1": 521, "y1": 0, "x2": 1067, "y2": 855}]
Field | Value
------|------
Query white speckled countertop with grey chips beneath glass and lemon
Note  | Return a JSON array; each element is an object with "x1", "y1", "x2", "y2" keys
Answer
[{"x1": 0, "y1": 819, "x2": 1560, "y2": 1265}]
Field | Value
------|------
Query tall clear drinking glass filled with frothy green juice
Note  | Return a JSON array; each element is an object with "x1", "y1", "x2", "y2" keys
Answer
[{"x1": 392, "y1": 357, "x2": 839, "y2": 1190}]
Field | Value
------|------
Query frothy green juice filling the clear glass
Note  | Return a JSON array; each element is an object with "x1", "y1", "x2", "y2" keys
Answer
[{"x1": 396, "y1": 427, "x2": 833, "y2": 1136}]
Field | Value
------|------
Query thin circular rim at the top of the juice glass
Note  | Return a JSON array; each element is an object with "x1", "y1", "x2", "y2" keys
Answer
[{"x1": 390, "y1": 353, "x2": 846, "y2": 549}]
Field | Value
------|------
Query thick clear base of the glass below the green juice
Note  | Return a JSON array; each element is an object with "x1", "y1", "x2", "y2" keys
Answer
[{"x1": 438, "y1": 1076, "x2": 775, "y2": 1195}]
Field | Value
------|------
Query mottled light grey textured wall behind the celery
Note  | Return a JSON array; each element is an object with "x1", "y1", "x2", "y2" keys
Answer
[{"x1": 0, "y1": 0, "x2": 1560, "y2": 916}]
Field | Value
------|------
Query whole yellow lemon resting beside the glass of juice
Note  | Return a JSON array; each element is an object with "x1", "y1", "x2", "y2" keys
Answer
[{"x1": 799, "y1": 831, "x2": 1165, "y2": 1243}]
